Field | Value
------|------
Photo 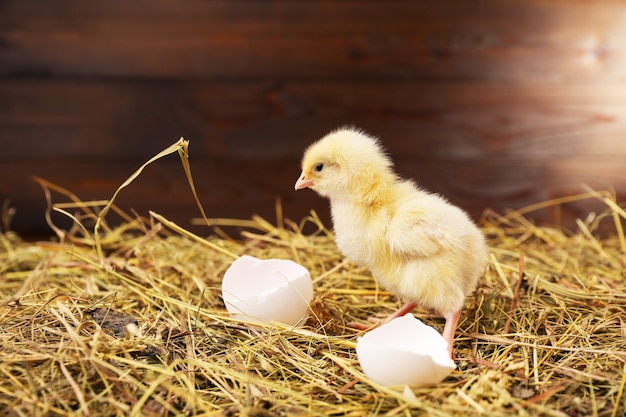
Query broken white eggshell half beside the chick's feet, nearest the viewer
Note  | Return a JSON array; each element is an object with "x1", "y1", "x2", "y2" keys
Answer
[{"x1": 356, "y1": 314, "x2": 456, "y2": 386}]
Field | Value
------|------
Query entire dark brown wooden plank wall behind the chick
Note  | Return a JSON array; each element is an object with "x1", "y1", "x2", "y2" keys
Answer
[{"x1": 0, "y1": 0, "x2": 626, "y2": 235}]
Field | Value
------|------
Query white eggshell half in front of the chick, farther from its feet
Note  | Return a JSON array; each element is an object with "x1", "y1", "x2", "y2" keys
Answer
[{"x1": 222, "y1": 255, "x2": 313, "y2": 326}]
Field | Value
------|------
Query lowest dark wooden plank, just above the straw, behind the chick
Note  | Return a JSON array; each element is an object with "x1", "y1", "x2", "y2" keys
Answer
[{"x1": 0, "y1": 155, "x2": 626, "y2": 236}]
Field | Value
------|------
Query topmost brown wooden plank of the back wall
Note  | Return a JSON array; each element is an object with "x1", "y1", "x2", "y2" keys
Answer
[{"x1": 0, "y1": 0, "x2": 626, "y2": 83}]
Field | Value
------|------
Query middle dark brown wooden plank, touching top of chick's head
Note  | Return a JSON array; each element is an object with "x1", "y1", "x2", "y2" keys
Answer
[{"x1": 0, "y1": 80, "x2": 626, "y2": 161}]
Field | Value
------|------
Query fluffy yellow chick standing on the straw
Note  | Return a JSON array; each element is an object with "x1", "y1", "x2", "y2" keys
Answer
[{"x1": 295, "y1": 127, "x2": 488, "y2": 355}]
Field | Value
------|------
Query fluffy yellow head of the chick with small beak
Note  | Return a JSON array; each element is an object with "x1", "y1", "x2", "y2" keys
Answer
[{"x1": 295, "y1": 127, "x2": 394, "y2": 199}]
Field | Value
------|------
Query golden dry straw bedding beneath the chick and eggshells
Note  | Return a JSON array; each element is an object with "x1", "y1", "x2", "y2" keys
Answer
[{"x1": 0, "y1": 141, "x2": 626, "y2": 417}]
